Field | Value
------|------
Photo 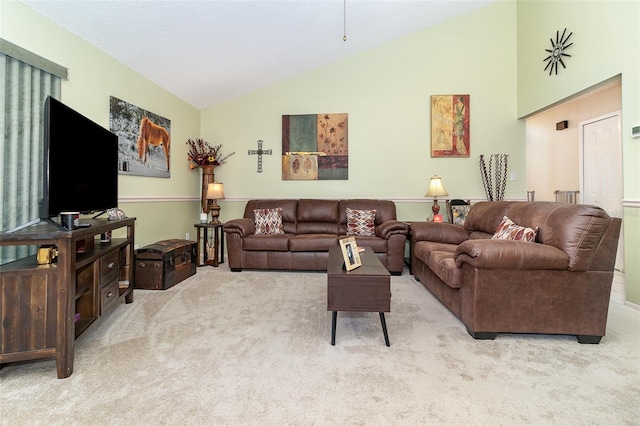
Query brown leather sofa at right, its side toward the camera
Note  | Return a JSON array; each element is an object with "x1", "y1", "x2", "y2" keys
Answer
[{"x1": 410, "y1": 201, "x2": 621, "y2": 343}]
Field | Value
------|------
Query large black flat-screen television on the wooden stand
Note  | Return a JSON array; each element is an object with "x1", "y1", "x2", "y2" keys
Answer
[{"x1": 40, "y1": 96, "x2": 118, "y2": 219}]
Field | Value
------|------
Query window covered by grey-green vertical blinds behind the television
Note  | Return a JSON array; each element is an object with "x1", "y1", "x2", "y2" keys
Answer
[{"x1": 0, "y1": 39, "x2": 67, "y2": 264}]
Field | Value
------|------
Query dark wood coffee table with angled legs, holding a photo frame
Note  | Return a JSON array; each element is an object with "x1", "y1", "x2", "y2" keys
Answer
[{"x1": 327, "y1": 246, "x2": 391, "y2": 346}]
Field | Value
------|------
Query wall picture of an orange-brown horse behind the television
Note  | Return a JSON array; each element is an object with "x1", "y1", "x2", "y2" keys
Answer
[{"x1": 109, "y1": 96, "x2": 171, "y2": 178}]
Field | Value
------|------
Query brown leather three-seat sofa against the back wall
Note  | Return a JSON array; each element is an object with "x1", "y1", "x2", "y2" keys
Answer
[{"x1": 224, "y1": 199, "x2": 408, "y2": 275}]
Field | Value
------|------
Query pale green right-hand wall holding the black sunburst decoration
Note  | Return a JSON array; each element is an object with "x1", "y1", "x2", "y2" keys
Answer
[{"x1": 517, "y1": 0, "x2": 640, "y2": 305}]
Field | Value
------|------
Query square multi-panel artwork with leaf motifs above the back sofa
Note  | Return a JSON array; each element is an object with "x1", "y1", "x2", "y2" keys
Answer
[{"x1": 282, "y1": 113, "x2": 349, "y2": 180}]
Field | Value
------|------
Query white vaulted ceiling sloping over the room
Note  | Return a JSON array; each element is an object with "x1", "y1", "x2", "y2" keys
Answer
[{"x1": 21, "y1": 0, "x2": 495, "y2": 109}]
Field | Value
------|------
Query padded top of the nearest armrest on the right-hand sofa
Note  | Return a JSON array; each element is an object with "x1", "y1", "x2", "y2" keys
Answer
[{"x1": 453, "y1": 240, "x2": 569, "y2": 270}]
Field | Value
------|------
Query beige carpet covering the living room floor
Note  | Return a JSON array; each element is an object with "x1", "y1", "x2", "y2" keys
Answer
[{"x1": 0, "y1": 265, "x2": 640, "y2": 425}]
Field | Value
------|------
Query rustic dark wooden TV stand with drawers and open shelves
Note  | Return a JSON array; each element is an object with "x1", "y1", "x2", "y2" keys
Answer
[{"x1": 0, "y1": 218, "x2": 135, "y2": 379}]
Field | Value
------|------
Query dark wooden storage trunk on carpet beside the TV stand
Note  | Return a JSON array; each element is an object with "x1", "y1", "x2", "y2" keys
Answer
[{"x1": 134, "y1": 239, "x2": 197, "y2": 290}]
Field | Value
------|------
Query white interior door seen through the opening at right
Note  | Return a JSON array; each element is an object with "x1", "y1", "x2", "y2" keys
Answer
[{"x1": 580, "y1": 112, "x2": 624, "y2": 271}]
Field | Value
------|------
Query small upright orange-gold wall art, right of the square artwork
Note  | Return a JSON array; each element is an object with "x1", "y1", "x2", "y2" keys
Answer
[{"x1": 431, "y1": 95, "x2": 471, "y2": 157}]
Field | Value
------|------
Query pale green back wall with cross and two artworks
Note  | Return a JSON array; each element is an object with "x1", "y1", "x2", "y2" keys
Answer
[{"x1": 201, "y1": 2, "x2": 526, "y2": 225}]
